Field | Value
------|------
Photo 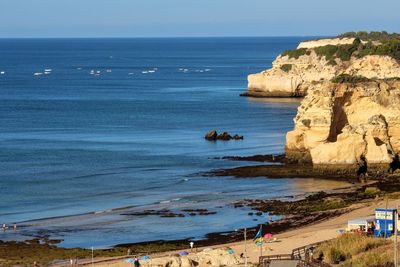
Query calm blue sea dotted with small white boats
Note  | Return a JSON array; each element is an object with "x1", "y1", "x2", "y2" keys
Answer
[{"x1": 0, "y1": 37, "x2": 346, "y2": 247}]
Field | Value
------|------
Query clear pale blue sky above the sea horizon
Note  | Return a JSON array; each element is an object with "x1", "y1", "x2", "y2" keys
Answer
[{"x1": 0, "y1": 0, "x2": 400, "y2": 37}]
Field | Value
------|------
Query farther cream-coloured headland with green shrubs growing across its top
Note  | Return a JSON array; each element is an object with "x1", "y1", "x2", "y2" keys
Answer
[{"x1": 247, "y1": 38, "x2": 400, "y2": 97}]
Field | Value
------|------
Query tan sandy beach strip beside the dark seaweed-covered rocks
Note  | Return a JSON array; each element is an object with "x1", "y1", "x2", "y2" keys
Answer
[{"x1": 57, "y1": 197, "x2": 400, "y2": 267}]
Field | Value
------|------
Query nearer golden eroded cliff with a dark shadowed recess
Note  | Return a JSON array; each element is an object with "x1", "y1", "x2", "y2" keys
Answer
[{"x1": 285, "y1": 80, "x2": 400, "y2": 174}]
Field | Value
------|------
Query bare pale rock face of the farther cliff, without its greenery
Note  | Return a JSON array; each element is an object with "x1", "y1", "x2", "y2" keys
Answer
[{"x1": 246, "y1": 38, "x2": 400, "y2": 97}]
